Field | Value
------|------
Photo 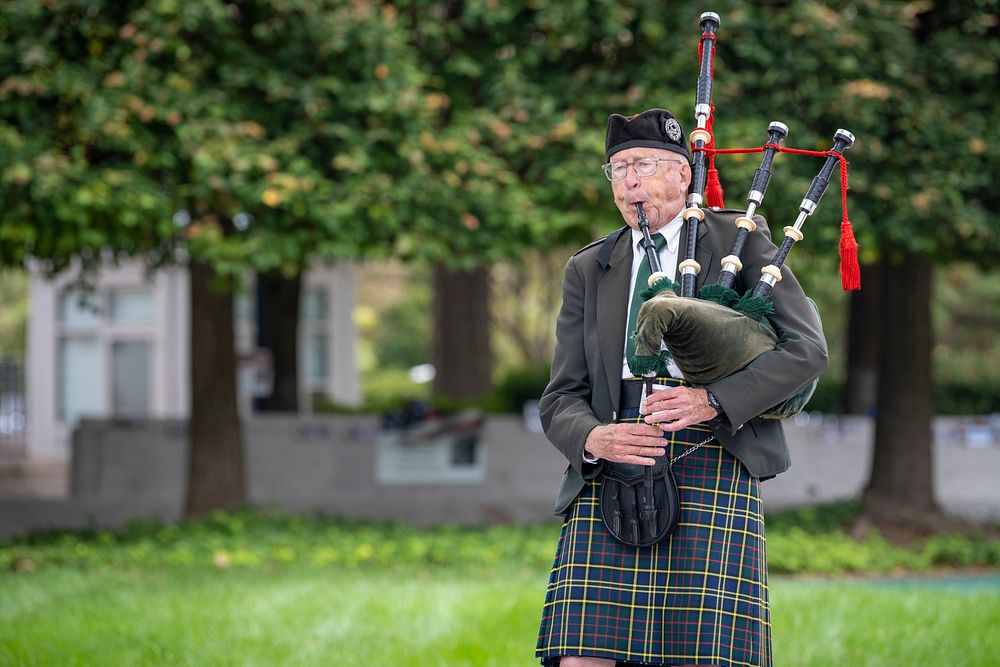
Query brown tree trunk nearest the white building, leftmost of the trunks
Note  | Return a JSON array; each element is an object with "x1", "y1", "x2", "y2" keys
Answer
[{"x1": 184, "y1": 260, "x2": 246, "y2": 517}]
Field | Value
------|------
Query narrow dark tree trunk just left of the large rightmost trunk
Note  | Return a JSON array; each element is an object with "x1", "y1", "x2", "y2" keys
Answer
[{"x1": 840, "y1": 264, "x2": 882, "y2": 416}]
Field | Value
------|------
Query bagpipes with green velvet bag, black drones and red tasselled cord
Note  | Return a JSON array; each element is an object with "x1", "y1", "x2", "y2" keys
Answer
[{"x1": 628, "y1": 12, "x2": 860, "y2": 418}]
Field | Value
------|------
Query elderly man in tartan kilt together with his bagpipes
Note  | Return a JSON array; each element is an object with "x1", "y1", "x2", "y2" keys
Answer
[{"x1": 536, "y1": 12, "x2": 857, "y2": 667}]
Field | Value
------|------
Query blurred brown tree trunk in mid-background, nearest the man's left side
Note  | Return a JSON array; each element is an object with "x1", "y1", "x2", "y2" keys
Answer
[{"x1": 432, "y1": 265, "x2": 493, "y2": 401}]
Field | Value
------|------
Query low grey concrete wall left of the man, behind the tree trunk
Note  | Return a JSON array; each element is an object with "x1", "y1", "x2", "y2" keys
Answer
[{"x1": 71, "y1": 416, "x2": 565, "y2": 525}]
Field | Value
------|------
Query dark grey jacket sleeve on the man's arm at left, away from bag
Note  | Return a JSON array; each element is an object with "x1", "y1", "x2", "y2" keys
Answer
[{"x1": 539, "y1": 256, "x2": 601, "y2": 478}]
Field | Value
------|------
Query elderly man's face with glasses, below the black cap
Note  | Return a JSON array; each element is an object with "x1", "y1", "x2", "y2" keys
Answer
[{"x1": 610, "y1": 148, "x2": 691, "y2": 232}]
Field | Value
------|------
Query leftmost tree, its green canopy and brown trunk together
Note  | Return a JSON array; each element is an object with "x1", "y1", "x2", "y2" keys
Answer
[{"x1": 0, "y1": 0, "x2": 423, "y2": 515}]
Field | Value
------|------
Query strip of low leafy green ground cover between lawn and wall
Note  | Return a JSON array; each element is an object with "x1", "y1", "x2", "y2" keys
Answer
[{"x1": 0, "y1": 503, "x2": 1000, "y2": 574}]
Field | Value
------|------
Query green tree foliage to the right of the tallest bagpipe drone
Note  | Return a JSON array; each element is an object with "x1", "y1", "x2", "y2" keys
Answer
[{"x1": 692, "y1": 0, "x2": 1000, "y2": 266}]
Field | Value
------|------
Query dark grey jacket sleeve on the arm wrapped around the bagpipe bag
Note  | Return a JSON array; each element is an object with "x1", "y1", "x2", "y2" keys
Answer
[{"x1": 708, "y1": 216, "x2": 828, "y2": 433}]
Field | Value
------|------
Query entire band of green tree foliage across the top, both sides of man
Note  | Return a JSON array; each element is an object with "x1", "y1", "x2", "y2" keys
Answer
[{"x1": 0, "y1": 0, "x2": 1000, "y2": 272}]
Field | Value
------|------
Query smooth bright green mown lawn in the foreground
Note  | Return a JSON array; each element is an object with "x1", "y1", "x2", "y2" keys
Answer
[{"x1": 0, "y1": 565, "x2": 1000, "y2": 667}]
